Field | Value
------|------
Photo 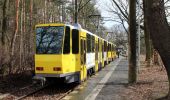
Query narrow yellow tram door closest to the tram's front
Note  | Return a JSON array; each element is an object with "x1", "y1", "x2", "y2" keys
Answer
[{"x1": 80, "y1": 39, "x2": 87, "y2": 80}]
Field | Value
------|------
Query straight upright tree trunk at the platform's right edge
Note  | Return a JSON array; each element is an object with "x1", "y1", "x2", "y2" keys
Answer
[{"x1": 129, "y1": 0, "x2": 137, "y2": 84}]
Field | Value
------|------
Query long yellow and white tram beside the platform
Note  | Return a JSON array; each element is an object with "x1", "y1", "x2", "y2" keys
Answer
[{"x1": 34, "y1": 23, "x2": 116, "y2": 83}]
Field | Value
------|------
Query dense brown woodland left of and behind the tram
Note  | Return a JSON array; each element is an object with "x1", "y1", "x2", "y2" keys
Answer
[{"x1": 0, "y1": 0, "x2": 107, "y2": 76}]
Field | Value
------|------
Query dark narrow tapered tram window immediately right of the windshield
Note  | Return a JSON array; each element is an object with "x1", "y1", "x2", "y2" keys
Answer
[{"x1": 63, "y1": 26, "x2": 70, "y2": 54}]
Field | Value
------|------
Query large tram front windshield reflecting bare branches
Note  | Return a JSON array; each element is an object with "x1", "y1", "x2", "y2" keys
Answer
[{"x1": 36, "y1": 26, "x2": 64, "y2": 54}]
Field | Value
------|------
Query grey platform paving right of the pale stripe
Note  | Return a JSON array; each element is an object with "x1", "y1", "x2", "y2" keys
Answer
[{"x1": 96, "y1": 60, "x2": 128, "y2": 100}]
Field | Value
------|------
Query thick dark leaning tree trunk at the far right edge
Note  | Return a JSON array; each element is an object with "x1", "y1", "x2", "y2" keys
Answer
[{"x1": 146, "y1": 0, "x2": 170, "y2": 99}]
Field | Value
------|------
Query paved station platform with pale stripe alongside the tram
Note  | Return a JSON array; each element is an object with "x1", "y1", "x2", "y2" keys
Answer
[{"x1": 63, "y1": 57, "x2": 128, "y2": 100}]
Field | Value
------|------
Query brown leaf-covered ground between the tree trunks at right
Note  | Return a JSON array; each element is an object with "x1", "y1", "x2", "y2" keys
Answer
[{"x1": 122, "y1": 56, "x2": 168, "y2": 100}]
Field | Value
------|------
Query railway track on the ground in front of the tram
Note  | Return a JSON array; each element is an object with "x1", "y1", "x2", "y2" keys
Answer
[{"x1": 0, "y1": 83, "x2": 79, "y2": 100}]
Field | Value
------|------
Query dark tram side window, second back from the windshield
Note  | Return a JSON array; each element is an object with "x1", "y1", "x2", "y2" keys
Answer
[{"x1": 72, "y1": 29, "x2": 79, "y2": 54}]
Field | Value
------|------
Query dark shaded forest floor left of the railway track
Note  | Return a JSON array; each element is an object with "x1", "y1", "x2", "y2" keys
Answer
[{"x1": 0, "y1": 71, "x2": 32, "y2": 100}]
